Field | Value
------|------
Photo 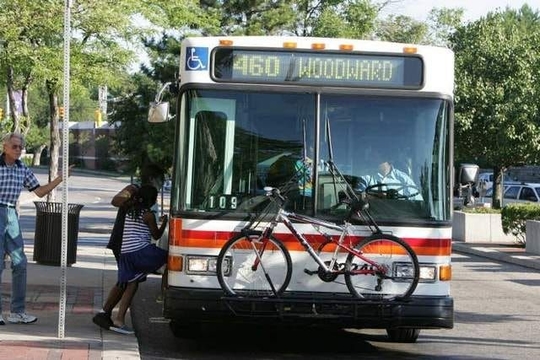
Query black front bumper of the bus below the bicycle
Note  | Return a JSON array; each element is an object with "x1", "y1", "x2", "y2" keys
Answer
[{"x1": 163, "y1": 288, "x2": 454, "y2": 329}]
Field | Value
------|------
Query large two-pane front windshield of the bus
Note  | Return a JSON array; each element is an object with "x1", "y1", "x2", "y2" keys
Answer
[{"x1": 171, "y1": 89, "x2": 451, "y2": 224}]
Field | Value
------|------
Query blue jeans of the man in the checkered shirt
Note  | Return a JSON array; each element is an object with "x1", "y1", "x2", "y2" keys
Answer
[{"x1": 0, "y1": 206, "x2": 27, "y2": 314}]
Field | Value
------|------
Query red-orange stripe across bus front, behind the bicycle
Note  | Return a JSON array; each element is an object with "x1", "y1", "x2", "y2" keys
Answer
[{"x1": 174, "y1": 230, "x2": 452, "y2": 256}]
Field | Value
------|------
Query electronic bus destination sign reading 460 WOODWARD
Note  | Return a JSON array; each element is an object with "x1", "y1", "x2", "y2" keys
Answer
[{"x1": 212, "y1": 48, "x2": 423, "y2": 89}]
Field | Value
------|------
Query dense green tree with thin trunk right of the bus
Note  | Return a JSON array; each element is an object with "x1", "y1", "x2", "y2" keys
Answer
[{"x1": 451, "y1": 9, "x2": 540, "y2": 208}]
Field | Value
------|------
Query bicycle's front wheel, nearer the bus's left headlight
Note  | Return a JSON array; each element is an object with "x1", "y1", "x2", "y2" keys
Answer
[{"x1": 216, "y1": 231, "x2": 292, "y2": 297}]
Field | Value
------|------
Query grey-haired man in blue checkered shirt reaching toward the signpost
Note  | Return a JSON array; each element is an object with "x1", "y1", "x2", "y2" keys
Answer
[{"x1": 0, "y1": 133, "x2": 71, "y2": 325}]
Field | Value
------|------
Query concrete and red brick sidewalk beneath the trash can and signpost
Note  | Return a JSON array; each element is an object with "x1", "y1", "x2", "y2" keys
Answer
[{"x1": 0, "y1": 236, "x2": 140, "y2": 360}]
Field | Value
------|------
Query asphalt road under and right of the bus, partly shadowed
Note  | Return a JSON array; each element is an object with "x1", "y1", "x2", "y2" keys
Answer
[{"x1": 133, "y1": 250, "x2": 540, "y2": 360}]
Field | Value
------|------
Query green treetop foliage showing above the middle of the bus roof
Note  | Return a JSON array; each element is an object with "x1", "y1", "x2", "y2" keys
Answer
[{"x1": 201, "y1": 0, "x2": 388, "y2": 38}]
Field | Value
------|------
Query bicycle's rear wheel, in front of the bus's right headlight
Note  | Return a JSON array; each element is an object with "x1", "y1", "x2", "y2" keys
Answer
[{"x1": 345, "y1": 234, "x2": 420, "y2": 300}]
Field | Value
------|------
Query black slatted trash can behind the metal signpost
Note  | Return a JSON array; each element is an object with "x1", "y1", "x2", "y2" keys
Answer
[{"x1": 34, "y1": 201, "x2": 84, "y2": 266}]
